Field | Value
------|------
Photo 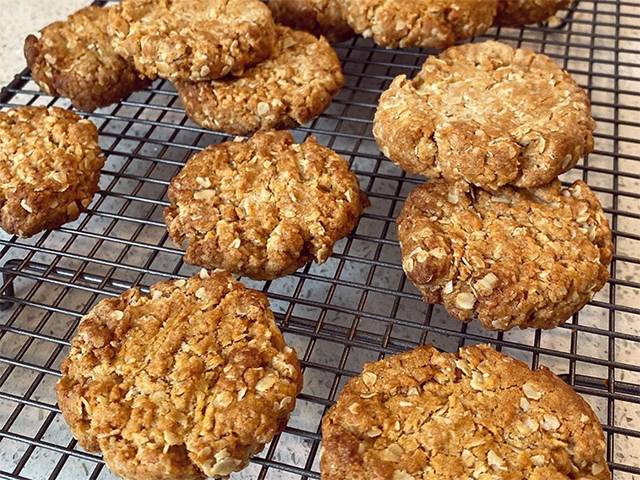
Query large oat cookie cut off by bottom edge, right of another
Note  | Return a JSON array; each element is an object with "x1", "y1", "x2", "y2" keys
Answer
[{"x1": 321, "y1": 345, "x2": 611, "y2": 480}]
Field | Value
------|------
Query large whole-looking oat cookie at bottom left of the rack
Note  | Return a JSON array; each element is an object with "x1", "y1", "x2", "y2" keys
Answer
[{"x1": 57, "y1": 270, "x2": 302, "y2": 480}]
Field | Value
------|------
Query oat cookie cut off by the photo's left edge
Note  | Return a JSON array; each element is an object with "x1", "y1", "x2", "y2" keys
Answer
[{"x1": 0, "y1": 107, "x2": 104, "y2": 237}]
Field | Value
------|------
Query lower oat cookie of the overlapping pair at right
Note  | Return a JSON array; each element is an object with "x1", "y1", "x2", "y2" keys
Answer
[{"x1": 398, "y1": 180, "x2": 612, "y2": 330}]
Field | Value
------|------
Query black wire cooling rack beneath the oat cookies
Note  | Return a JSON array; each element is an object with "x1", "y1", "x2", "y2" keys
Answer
[{"x1": 0, "y1": 0, "x2": 640, "y2": 479}]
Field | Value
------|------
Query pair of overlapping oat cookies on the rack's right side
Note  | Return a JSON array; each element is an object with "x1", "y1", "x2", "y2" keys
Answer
[{"x1": 373, "y1": 42, "x2": 612, "y2": 330}]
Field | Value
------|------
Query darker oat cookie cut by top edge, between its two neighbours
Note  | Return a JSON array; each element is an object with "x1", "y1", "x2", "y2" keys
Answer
[{"x1": 268, "y1": 0, "x2": 354, "y2": 42}]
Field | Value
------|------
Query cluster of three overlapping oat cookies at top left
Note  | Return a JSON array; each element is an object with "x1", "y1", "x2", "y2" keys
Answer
[{"x1": 25, "y1": 0, "x2": 344, "y2": 134}]
